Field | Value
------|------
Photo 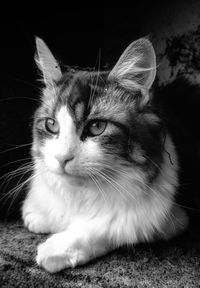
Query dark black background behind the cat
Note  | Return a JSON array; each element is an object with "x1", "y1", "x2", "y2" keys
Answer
[{"x1": 0, "y1": 0, "x2": 200, "y2": 222}]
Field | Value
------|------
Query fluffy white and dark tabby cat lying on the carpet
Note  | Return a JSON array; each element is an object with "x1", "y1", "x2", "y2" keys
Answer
[{"x1": 22, "y1": 38, "x2": 188, "y2": 273}]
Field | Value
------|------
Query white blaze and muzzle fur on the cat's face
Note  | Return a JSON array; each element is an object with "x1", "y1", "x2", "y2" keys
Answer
[{"x1": 42, "y1": 106, "x2": 102, "y2": 176}]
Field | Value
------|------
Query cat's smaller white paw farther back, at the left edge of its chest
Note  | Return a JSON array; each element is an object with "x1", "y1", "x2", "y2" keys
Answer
[{"x1": 23, "y1": 212, "x2": 51, "y2": 233}]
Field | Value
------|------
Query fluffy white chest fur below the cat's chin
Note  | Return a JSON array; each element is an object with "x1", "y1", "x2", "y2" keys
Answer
[{"x1": 24, "y1": 139, "x2": 181, "y2": 244}]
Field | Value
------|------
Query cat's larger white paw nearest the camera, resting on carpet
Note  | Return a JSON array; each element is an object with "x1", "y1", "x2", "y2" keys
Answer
[{"x1": 36, "y1": 233, "x2": 89, "y2": 273}]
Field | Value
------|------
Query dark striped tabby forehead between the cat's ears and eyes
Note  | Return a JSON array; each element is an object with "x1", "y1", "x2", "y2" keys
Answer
[{"x1": 40, "y1": 71, "x2": 138, "y2": 126}]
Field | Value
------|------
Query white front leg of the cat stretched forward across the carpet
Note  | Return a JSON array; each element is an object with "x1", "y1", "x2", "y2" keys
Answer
[{"x1": 36, "y1": 220, "x2": 110, "y2": 273}]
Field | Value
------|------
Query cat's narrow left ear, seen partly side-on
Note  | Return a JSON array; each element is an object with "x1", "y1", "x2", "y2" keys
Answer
[{"x1": 35, "y1": 37, "x2": 62, "y2": 86}]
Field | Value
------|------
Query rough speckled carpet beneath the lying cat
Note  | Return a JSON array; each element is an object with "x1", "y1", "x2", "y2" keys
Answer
[{"x1": 0, "y1": 222, "x2": 200, "y2": 288}]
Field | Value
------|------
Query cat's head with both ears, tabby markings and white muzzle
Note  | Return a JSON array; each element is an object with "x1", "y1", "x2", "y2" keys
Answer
[{"x1": 32, "y1": 38, "x2": 162, "y2": 185}]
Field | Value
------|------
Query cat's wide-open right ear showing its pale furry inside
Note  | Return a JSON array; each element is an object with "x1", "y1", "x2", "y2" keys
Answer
[{"x1": 109, "y1": 38, "x2": 156, "y2": 102}]
